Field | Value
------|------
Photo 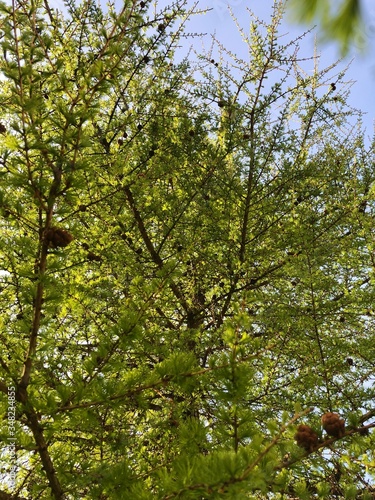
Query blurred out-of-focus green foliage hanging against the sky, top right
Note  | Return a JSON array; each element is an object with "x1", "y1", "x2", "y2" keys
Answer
[{"x1": 291, "y1": 0, "x2": 363, "y2": 55}]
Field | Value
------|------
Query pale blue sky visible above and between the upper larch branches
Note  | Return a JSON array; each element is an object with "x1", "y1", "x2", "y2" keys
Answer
[{"x1": 50, "y1": 0, "x2": 375, "y2": 137}]
